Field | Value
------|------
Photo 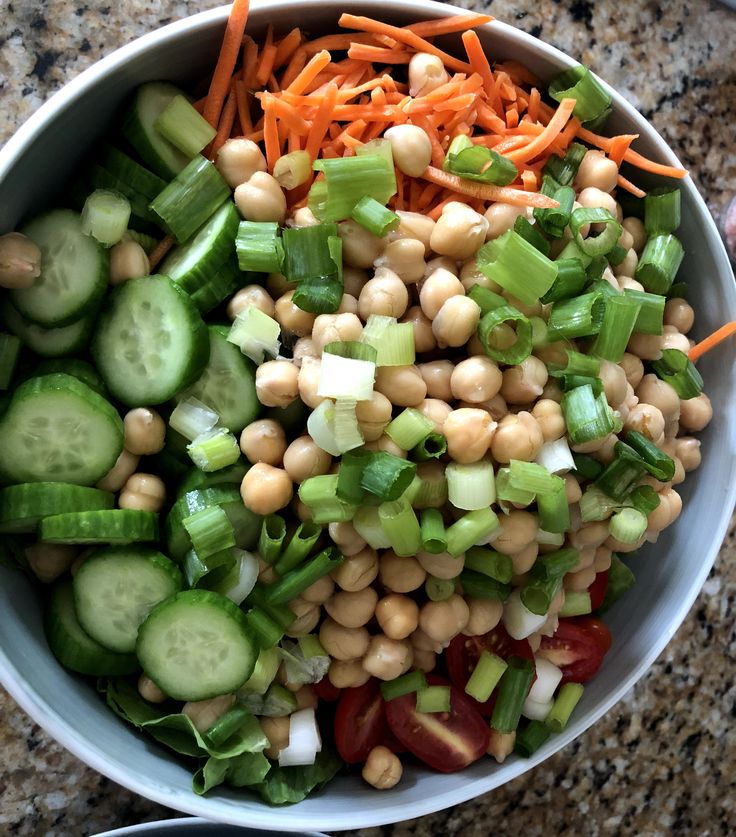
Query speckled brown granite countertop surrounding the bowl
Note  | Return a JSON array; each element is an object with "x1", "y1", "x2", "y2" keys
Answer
[{"x1": 0, "y1": 0, "x2": 736, "y2": 837}]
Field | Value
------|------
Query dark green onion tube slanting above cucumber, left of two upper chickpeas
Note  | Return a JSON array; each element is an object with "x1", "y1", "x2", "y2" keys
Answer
[{"x1": 151, "y1": 155, "x2": 231, "y2": 244}]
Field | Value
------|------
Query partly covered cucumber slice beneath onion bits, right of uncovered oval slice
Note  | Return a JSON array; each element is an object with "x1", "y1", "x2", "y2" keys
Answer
[{"x1": 181, "y1": 326, "x2": 261, "y2": 433}]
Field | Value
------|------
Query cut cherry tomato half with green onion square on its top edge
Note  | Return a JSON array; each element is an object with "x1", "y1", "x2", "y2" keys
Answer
[{"x1": 386, "y1": 675, "x2": 490, "y2": 773}]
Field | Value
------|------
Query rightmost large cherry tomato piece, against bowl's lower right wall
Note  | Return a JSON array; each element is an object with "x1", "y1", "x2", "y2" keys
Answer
[{"x1": 538, "y1": 616, "x2": 612, "y2": 683}]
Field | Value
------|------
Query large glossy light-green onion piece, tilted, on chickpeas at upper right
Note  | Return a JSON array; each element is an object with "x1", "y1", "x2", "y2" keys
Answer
[{"x1": 476, "y1": 230, "x2": 557, "y2": 305}]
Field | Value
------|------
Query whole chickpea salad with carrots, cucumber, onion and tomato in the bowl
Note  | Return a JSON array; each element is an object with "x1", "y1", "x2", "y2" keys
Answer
[{"x1": 0, "y1": 2, "x2": 728, "y2": 804}]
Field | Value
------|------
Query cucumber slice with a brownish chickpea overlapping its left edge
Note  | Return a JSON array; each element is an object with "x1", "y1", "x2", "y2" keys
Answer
[{"x1": 10, "y1": 209, "x2": 110, "y2": 327}]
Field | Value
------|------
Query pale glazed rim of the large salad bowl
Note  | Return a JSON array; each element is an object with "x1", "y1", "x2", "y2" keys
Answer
[{"x1": 0, "y1": 0, "x2": 736, "y2": 831}]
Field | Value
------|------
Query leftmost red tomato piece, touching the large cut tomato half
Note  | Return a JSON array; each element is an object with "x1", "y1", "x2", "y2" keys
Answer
[{"x1": 335, "y1": 678, "x2": 388, "y2": 764}]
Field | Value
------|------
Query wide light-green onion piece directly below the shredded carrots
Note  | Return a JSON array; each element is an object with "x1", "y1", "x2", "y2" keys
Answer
[{"x1": 308, "y1": 154, "x2": 396, "y2": 221}]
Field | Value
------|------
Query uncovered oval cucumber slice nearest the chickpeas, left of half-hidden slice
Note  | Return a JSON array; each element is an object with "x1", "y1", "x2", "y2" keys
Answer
[{"x1": 92, "y1": 276, "x2": 209, "y2": 407}]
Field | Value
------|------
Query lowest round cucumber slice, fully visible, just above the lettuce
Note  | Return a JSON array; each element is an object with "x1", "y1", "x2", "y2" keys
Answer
[{"x1": 136, "y1": 590, "x2": 258, "y2": 701}]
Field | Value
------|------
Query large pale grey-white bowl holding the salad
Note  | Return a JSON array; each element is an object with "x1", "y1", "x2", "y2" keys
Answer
[{"x1": 0, "y1": 0, "x2": 736, "y2": 831}]
